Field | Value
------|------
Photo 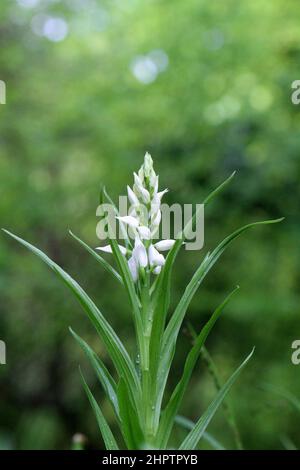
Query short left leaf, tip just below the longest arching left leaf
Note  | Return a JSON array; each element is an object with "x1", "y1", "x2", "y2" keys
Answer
[{"x1": 69, "y1": 328, "x2": 119, "y2": 418}]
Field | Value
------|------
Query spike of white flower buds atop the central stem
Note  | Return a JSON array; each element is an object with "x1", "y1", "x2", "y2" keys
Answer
[{"x1": 96, "y1": 153, "x2": 175, "y2": 282}]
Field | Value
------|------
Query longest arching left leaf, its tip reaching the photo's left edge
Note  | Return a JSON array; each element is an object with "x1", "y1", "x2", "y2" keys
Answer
[{"x1": 3, "y1": 229, "x2": 141, "y2": 400}]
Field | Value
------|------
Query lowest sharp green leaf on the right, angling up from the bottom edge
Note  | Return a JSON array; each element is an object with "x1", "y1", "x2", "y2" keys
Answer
[{"x1": 179, "y1": 349, "x2": 254, "y2": 450}]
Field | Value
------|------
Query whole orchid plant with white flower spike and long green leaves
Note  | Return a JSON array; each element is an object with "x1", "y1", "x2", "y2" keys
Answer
[{"x1": 5, "y1": 153, "x2": 282, "y2": 450}]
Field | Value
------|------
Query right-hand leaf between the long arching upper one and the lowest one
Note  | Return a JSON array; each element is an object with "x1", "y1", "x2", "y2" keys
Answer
[{"x1": 159, "y1": 287, "x2": 239, "y2": 447}]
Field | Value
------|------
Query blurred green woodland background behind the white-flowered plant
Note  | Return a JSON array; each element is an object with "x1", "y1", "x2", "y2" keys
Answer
[{"x1": 0, "y1": 0, "x2": 300, "y2": 449}]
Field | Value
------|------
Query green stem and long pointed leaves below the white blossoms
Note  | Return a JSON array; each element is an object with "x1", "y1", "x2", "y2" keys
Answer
[{"x1": 4, "y1": 171, "x2": 282, "y2": 450}]
